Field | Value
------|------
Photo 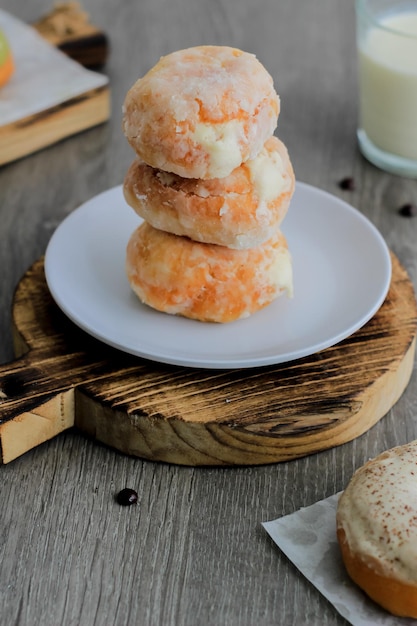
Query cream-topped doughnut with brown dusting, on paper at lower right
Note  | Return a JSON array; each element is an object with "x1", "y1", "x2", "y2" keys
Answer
[{"x1": 337, "y1": 441, "x2": 417, "y2": 618}]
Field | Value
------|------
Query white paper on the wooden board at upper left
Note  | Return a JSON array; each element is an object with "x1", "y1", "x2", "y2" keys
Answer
[{"x1": 0, "y1": 9, "x2": 109, "y2": 127}]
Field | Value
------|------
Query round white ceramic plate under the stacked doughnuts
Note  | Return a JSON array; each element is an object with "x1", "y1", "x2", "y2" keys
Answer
[{"x1": 45, "y1": 183, "x2": 391, "y2": 369}]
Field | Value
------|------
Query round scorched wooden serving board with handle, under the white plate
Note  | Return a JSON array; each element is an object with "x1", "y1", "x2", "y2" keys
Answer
[{"x1": 0, "y1": 255, "x2": 417, "y2": 465}]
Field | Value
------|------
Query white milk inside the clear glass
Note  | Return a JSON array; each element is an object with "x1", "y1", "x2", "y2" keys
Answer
[{"x1": 359, "y1": 11, "x2": 417, "y2": 161}]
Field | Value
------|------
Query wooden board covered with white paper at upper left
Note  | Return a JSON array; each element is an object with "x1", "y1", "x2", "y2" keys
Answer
[{"x1": 0, "y1": 3, "x2": 110, "y2": 166}]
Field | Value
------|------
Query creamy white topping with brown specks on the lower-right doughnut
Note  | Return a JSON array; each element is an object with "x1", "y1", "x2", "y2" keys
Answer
[{"x1": 337, "y1": 441, "x2": 417, "y2": 583}]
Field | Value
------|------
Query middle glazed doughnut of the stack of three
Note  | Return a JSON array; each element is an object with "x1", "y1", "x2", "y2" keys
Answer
[{"x1": 123, "y1": 137, "x2": 295, "y2": 250}]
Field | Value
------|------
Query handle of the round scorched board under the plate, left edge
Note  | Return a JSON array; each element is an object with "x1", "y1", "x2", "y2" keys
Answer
[{"x1": 0, "y1": 352, "x2": 74, "y2": 464}]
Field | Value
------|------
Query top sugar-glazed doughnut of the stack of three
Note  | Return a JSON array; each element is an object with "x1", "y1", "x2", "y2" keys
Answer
[{"x1": 123, "y1": 46, "x2": 279, "y2": 179}]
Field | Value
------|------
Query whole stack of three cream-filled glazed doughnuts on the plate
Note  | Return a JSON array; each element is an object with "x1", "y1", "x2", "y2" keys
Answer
[{"x1": 123, "y1": 46, "x2": 295, "y2": 322}]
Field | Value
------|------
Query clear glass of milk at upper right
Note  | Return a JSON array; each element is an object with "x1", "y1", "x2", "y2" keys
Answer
[{"x1": 356, "y1": 0, "x2": 417, "y2": 178}]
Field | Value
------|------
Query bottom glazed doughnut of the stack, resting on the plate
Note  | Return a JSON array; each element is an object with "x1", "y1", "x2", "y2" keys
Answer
[{"x1": 126, "y1": 222, "x2": 292, "y2": 322}]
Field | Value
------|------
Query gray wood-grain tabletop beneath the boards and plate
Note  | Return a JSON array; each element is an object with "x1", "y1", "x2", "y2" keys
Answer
[{"x1": 0, "y1": 0, "x2": 417, "y2": 626}]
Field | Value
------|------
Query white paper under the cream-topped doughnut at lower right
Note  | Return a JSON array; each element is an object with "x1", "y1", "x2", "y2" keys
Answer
[{"x1": 262, "y1": 494, "x2": 417, "y2": 626}]
